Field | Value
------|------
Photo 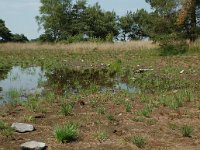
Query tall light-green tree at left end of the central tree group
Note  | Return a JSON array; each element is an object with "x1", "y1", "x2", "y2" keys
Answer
[{"x1": 36, "y1": 0, "x2": 72, "y2": 41}]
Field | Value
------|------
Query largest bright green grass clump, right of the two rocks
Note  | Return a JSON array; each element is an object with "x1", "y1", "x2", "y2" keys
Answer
[{"x1": 54, "y1": 122, "x2": 78, "y2": 143}]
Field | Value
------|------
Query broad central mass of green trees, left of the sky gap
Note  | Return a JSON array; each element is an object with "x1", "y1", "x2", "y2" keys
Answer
[{"x1": 36, "y1": 0, "x2": 118, "y2": 41}]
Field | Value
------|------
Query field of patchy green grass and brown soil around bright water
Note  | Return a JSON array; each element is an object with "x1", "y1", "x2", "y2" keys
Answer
[{"x1": 0, "y1": 42, "x2": 200, "y2": 150}]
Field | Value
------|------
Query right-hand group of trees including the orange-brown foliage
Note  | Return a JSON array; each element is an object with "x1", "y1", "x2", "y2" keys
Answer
[{"x1": 143, "y1": 0, "x2": 200, "y2": 41}]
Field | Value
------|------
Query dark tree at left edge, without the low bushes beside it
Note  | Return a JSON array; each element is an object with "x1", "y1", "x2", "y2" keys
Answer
[{"x1": 0, "y1": 19, "x2": 12, "y2": 42}]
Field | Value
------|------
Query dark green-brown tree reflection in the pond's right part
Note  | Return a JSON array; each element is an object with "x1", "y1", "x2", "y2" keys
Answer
[{"x1": 46, "y1": 68, "x2": 139, "y2": 93}]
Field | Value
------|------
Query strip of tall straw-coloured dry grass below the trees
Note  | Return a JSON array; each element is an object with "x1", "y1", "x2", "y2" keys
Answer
[{"x1": 0, "y1": 41, "x2": 157, "y2": 52}]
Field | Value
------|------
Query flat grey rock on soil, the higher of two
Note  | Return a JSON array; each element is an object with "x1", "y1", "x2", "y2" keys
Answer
[{"x1": 11, "y1": 123, "x2": 34, "y2": 133}]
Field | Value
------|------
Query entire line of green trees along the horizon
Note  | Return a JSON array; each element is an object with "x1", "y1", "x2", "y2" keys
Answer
[{"x1": 0, "y1": 0, "x2": 200, "y2": 45}]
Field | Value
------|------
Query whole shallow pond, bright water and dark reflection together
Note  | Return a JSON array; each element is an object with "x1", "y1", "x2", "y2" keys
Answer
[{"x1": 0, "y1": 66, "x2": 139, "y2": 104}]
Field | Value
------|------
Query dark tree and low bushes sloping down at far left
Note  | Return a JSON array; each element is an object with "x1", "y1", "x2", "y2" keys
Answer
[{"x1": 0, "y1": 19, "x2": 28, "y2": 42}]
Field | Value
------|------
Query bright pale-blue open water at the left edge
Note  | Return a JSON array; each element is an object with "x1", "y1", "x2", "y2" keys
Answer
[{"x1": 0, "y1": 66, "x2": 47, "y2": 104}]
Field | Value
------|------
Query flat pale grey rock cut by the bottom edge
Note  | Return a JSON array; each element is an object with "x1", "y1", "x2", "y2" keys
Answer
[{"x1": 20, "y1": 141, "x2": 46, "y2": 150}]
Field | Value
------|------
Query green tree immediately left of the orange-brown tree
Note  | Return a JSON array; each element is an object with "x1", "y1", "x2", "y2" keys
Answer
[{"x1": 143, "y1": 0, "x2": 181, "y2": 41}]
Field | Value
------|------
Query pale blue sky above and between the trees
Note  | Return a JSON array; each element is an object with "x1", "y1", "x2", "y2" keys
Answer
[{"x1": 0, "y1": 0, "x2": 150, "y2": 39}]
